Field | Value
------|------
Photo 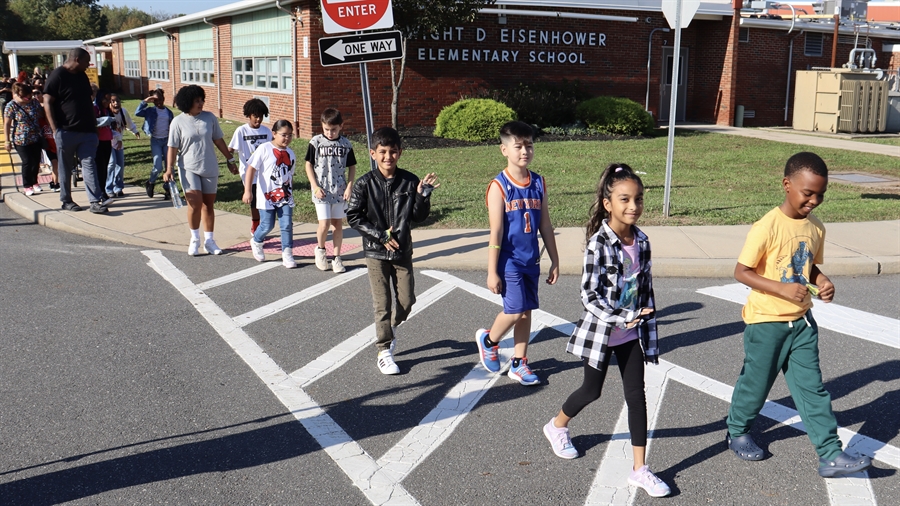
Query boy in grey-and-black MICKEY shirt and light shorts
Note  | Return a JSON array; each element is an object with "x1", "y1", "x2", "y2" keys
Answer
[{"x1": 306, "y1": 108, "x2": 356, "y2": 272}]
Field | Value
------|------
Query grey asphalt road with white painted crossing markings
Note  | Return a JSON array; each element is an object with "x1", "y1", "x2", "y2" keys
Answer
[{"x1": 0, "y1": 205, "x2": 900, "y2": 506}]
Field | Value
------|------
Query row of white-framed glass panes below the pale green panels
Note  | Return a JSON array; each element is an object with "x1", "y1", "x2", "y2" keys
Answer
[{"x1": 125, "y1": 56, "x2": 294, "y2": 91}]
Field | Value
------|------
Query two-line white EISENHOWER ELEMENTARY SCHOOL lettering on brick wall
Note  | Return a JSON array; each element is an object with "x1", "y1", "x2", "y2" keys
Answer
[{"x1": 417, "y1": 26, "x2": 606, "y2": 65}]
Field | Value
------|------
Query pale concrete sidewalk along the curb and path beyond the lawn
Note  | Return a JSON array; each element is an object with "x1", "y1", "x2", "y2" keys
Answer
[{"x1": 0, "y1": 125, "x2": 900, "y2": 277}]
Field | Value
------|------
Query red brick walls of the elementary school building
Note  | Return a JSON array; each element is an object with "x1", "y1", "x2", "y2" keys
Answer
[{"x1": 105, "y1": 2, "x2": 898, "y2": 137}]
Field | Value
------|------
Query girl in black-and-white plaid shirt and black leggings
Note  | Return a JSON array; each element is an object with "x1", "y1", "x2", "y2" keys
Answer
[{"x1": 544, "y1": 164, "x2": 670, "y2": 497}]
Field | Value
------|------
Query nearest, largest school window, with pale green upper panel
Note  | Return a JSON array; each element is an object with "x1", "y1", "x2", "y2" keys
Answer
[{"x1": 231, "y1": 9, "x2": 294, "y2": 92}]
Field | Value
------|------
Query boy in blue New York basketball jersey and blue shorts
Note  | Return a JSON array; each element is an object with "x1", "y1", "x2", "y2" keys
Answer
[{"x1": 475, "y1": 121, "x2": 559, "y2": 386}]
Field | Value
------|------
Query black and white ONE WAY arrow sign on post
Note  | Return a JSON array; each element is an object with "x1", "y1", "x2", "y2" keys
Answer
[{"x1": 319, "y1": 31, "x2": 403, "y2": 67}]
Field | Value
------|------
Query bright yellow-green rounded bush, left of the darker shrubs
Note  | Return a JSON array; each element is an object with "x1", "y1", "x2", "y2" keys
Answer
[{"x1": 434, "y1": 98, "x2": 516, "y2": 142}]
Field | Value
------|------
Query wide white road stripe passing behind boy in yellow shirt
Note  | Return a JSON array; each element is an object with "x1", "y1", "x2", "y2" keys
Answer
[{"x1": 697, "y1": 283, "x2": 900, "y2": 349}]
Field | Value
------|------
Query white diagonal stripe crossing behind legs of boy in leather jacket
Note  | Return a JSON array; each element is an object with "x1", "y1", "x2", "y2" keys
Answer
[{"x1": 291, "y1": 283, "x2": 454, "y2": 388}]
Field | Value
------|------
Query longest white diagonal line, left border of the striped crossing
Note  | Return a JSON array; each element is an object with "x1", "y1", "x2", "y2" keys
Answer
[{"x1": 142, "y1": 250, "x2": 418, "y2": 505}]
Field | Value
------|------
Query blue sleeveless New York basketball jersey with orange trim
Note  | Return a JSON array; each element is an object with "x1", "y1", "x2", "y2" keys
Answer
[{"x1": 491, "y1": 170, "x2": 544, "y2": 273}]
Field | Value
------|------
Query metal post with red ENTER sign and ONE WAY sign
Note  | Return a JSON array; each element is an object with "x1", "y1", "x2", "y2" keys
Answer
[{"x1": 319, "y1": 0, "x2": 403, "y2": 170}]
